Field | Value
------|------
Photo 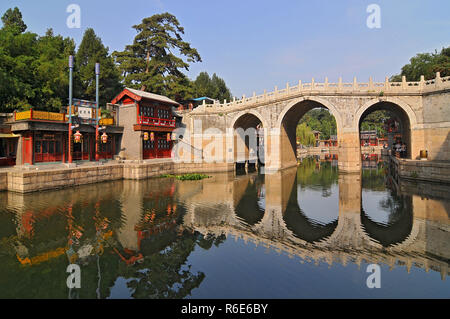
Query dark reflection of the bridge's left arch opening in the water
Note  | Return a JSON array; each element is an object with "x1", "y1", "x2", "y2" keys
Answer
[{"x1": 235, "y1": 175, "x2": 265, "y2": 226}]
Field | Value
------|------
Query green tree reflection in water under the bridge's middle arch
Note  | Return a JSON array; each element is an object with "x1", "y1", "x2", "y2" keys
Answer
[{"x1": 297, "y1": 157, "x2": 338, "y2": 197}]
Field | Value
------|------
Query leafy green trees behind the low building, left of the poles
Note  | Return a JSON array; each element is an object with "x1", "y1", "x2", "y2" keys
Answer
[{"x1": 0, "y1": 11, "x2": 75, "y2": 112}]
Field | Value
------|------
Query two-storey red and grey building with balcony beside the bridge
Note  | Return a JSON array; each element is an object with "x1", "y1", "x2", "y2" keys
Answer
[{"x1": 111, "y1": 88, "x2": 180, "y2": 160}]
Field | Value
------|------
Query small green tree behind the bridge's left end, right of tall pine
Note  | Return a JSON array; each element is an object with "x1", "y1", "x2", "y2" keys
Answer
[{"x1": 194, "y1": 72, "x2": 232, "y2": 102}]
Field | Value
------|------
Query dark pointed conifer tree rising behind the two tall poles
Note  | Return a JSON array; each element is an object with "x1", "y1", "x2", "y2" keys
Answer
[{"x1": 74, "y1": 28, "x2": 122, "y2": 105}]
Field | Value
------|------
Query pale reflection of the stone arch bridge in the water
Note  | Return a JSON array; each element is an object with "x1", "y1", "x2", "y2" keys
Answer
[{"x1": 184, "y1": 164, "x2": 450, "y2": 279}]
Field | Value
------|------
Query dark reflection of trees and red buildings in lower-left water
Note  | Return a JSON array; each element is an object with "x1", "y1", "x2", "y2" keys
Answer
[{"x1": 0, "y1": 188, "x2": 229, "y2": 298}]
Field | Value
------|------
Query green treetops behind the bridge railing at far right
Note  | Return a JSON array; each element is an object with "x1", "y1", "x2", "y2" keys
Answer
[{"x1": 390, "y1": 47, "x2": 450, "y2": 82}]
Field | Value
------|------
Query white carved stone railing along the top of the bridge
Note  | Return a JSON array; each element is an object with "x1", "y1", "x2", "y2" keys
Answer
[{"x1": 193, "y1": 72, "x2": 450, "y2": 113}]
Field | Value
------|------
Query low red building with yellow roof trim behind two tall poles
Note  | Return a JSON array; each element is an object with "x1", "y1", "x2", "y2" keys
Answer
[{"x1": 10, "y1": 105, "x2": 123, "y2": 165}]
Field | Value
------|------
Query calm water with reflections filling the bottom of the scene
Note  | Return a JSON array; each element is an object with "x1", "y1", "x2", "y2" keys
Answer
[{"x1": 0, "y1": 158, "x2": 450, "y2": 298}]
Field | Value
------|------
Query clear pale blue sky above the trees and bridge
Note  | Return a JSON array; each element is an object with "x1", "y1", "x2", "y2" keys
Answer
[{"x1": 0, "y1": 0, "x2": 450, "y2": 97}]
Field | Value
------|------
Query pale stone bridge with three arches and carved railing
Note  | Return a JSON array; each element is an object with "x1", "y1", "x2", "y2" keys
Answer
[{"x1": 180, "y1": 73, "x2": 450, "y2": 172}]
